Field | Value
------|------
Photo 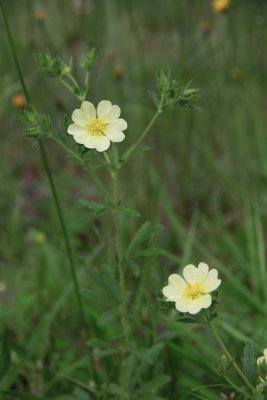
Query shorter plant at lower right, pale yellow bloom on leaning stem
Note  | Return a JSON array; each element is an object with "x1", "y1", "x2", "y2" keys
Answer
[{"x1": 163, "y1": 262, "x2": 267, "y2": 400}]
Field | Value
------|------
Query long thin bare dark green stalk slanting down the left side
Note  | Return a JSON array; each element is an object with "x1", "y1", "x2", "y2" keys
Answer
[{"x1": 0, "y1": 0, "x2": 96, "y2": 377}]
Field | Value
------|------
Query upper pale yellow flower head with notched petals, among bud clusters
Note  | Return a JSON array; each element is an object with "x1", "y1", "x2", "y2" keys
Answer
[{"x1": 67, "y1": 100, "x2": 127, "y2": 151}]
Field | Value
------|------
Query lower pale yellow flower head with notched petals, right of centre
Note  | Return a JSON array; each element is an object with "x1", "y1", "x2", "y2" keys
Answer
[{"x1": 162, "y1": 262, "x2": 221, "y2": 314}]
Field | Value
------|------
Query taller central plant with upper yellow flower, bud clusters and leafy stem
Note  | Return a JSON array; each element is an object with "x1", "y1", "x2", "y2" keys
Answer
[{"x1": 15, "y1": 43, "x2": 205, "y2": 400}]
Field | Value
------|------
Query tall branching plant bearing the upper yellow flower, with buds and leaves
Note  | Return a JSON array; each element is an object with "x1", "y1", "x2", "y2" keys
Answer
[{"x1": 19, "y1": 49, "x2": 204, "y2": 400}]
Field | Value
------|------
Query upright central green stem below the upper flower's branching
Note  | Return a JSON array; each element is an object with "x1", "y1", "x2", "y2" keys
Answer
[{"x1": 112, "y1": 170, "x2": 128, "y2": 400}]
